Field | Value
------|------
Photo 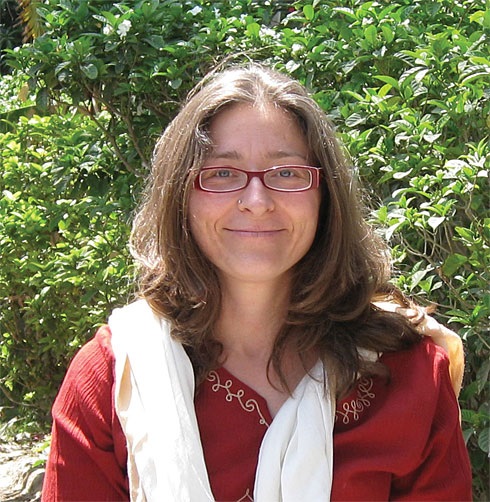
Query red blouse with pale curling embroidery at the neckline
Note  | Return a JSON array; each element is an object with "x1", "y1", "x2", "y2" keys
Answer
[{"x1": 43, "y1": 327, "x2": 471, "y2": 501}]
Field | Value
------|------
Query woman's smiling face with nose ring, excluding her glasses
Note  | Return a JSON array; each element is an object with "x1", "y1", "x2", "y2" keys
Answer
[{"x1": 189, "y1": 104, "x2": 321, "y2": 284}]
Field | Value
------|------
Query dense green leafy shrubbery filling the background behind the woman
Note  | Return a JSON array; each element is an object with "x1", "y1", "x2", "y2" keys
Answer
[{"x1": 0, "y1": 0, "x2": 490, "y2": 500}]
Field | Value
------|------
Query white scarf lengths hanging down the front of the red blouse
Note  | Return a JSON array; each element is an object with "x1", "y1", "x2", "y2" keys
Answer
[{"x1": 109, "y1": 300, "x2": 335, "y2": 502}]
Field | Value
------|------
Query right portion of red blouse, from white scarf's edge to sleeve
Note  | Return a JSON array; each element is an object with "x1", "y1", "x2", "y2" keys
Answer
[{"x1": 332, "y1": 340, "x2": 472, "y2": 502}]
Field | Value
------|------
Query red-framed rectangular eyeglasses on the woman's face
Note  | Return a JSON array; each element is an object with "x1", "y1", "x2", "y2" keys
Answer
[{"x1": 194, "y1": 166, "x2": 321, "y2": 193}]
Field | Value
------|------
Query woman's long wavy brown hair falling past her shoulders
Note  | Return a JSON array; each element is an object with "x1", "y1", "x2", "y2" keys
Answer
[{"x1": 131, "y1": 64, "x2": 420, "y2": 400}]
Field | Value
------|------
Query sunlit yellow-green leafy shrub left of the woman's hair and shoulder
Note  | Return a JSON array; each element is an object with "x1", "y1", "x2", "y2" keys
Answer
[{"x1": 0, "y1": 114, "x2": 134, "y2": 418}]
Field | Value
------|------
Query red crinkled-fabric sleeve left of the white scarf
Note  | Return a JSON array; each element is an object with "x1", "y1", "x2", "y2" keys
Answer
[{"x1": 42, "y1": 327, "x2": 129, "y2": 502}]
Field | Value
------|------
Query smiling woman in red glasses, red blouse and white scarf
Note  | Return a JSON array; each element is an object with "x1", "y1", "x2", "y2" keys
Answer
[{"x1": 43, "y1": 65, "x2": 471, "y2": 502}]
